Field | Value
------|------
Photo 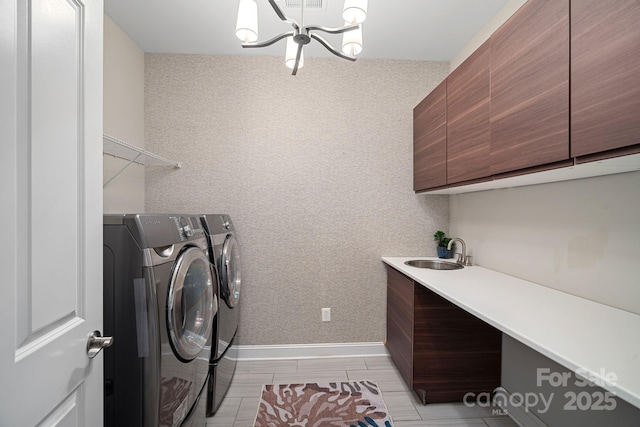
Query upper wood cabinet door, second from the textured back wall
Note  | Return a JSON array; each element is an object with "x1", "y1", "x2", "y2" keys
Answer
[{"x1": 447, "y1": 42, "x2": 491, "y2": 184}]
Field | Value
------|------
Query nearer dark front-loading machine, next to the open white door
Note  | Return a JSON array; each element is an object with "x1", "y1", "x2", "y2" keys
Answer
[{"x1": 103, "y1": 214, "x2": 218, "y2": 427}]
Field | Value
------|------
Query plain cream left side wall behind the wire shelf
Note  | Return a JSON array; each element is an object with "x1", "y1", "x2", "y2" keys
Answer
[{"x1": 103, "y1": 15, "x2": 145, "y2": 213}]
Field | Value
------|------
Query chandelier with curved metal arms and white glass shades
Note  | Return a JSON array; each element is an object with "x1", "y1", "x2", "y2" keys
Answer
[{"x1": 236, "y1": 0, "x2": 367, "y2": 76}]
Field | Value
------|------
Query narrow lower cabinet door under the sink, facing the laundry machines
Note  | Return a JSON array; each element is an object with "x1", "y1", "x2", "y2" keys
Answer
[{"x1": 386, "y1": 267, "x2": 413, "y2": 387}]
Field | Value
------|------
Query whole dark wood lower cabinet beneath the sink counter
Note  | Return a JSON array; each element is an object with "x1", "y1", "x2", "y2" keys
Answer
[{"x1": 386, "y1": 267, "x2": 502, "y2": 404}]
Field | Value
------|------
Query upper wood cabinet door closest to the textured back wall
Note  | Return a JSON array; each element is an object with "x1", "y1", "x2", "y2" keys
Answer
[{"x1": 413, "y1": 80, "x2": 447, "y2": 191}]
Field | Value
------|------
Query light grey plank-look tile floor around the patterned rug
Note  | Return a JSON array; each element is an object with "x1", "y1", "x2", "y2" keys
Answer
[{"x1": 207, "y1": 357, "x2": 517, "y2": 427}]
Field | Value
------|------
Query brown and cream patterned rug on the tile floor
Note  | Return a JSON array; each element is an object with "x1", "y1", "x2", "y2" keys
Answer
[{"x1": 253, "y1": 380, "x2": 392, "y2": 427}]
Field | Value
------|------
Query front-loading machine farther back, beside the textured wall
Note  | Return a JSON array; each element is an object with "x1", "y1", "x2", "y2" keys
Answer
[{"x1": 202, "y1": 214, "x2": 242, "y2": 416}]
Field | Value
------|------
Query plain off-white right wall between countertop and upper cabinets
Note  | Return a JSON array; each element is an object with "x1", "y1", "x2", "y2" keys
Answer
[{"x1": 450, "y1": 172, "x2": 640, "y2": 314}]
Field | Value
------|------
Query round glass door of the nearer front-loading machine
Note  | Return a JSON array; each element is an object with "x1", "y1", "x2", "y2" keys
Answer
[{"x1": 167, "y1": 247, "x2": 218, "y2": 362}]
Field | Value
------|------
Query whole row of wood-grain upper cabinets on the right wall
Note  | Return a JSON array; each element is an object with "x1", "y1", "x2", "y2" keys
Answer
[{"x1": 414, "y1": 0, "x2": 640, "y2": 194}]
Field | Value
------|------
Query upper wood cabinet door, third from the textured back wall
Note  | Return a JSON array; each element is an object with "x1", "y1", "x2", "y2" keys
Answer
[{"x1": 490, "y1": 0, "x2": 568, "y2": 174}]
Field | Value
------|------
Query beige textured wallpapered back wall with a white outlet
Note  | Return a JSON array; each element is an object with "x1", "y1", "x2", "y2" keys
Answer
[{"x1": 145, "y1": 54, "x2": 449, "y2": 344}]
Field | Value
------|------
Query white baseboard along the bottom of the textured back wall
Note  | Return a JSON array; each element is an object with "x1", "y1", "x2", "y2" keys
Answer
[{"x1": 236, "y1": 342, "x2": 389, "y2": 360}]
